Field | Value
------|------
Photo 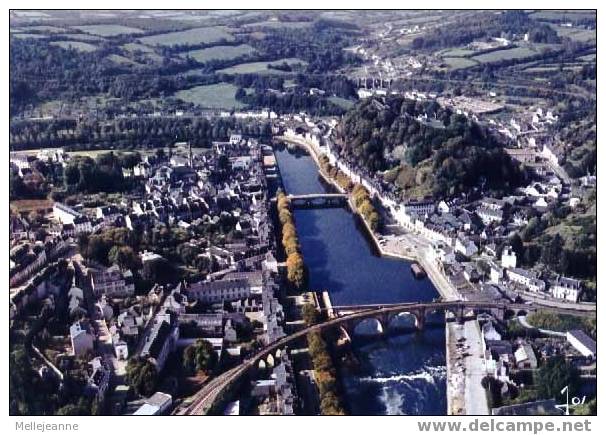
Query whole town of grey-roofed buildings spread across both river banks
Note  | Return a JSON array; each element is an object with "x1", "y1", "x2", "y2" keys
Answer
[{"x1": 9, "y1": 8, "x2": 597, "y2": 416}]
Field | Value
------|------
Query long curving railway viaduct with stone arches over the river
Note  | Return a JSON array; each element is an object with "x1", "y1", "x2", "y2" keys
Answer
[{"x1": 175, "y1": 301, "x2": 570, "y2": 415}]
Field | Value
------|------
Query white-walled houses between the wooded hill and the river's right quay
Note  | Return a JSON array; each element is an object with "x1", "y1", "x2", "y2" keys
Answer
[{"x1": 285, "y1": 116, "x2": 583, "y2": 302}]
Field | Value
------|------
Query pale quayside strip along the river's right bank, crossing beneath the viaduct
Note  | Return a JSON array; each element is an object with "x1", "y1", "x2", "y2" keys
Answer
[{"x1": 276, "y1": 136, "x2": 489, "y2": 415}]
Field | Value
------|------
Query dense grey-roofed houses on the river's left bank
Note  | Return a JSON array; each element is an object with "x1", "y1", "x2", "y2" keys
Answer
[{"x1": 11, "y1": 134, "x2": 297, "y2": 415}]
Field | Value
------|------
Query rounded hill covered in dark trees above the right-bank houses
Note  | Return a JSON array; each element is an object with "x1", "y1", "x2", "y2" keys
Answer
[{"x1": 338, "y1": 97, "x2": 526, "y2": 197}]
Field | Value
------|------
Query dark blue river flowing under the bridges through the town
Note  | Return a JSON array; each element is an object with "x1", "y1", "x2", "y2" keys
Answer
[{"x1": 276, "y1": 148, "x2": 446, "y2": 415}]
